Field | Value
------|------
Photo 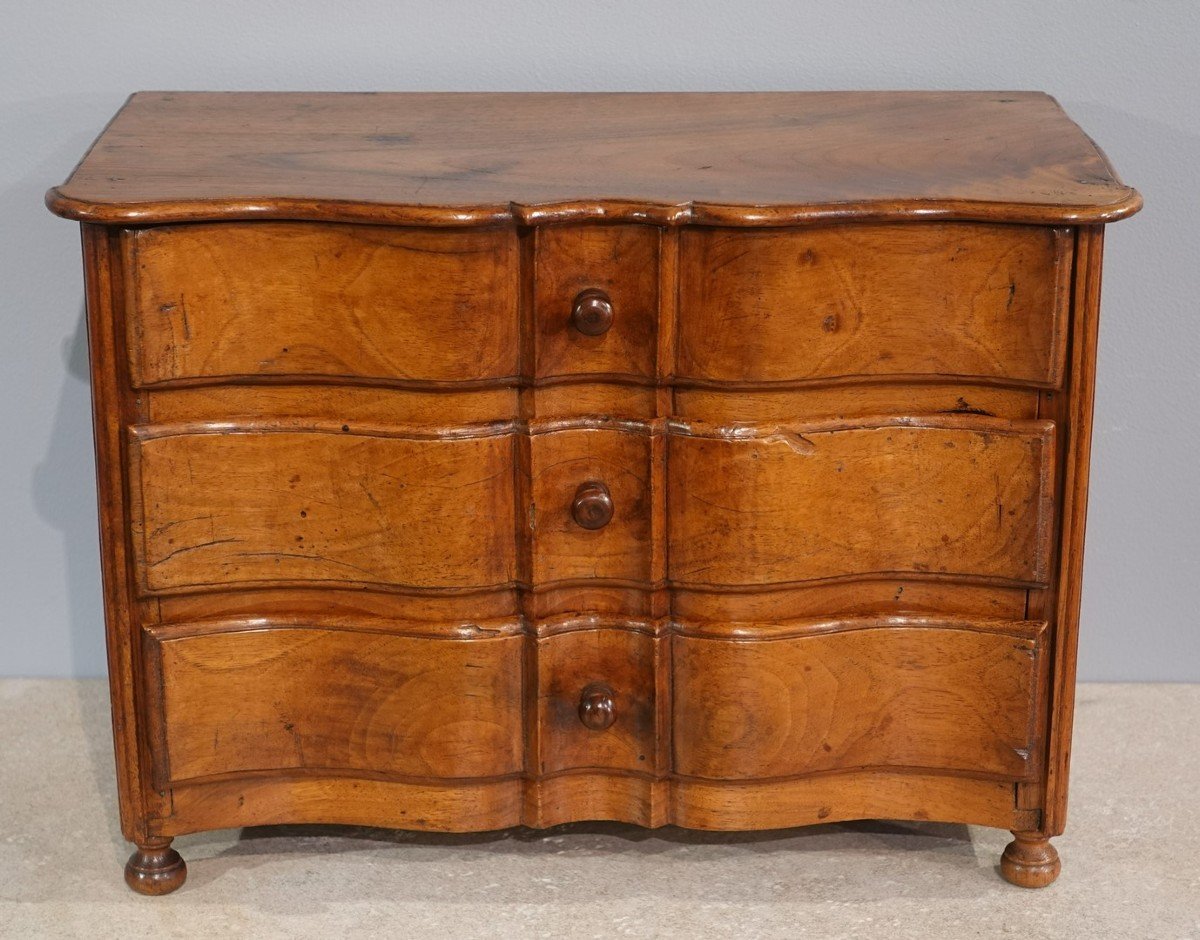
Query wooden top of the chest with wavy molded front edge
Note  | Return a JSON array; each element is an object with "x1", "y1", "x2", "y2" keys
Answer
[{"x1": 47, "y1": 91, "x2": 1141, "y2": 226}]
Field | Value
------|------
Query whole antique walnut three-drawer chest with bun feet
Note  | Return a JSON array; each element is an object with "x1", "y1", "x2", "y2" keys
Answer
[{"x1": 47, "y1": 92, "x2": 1140, "y2": 893}]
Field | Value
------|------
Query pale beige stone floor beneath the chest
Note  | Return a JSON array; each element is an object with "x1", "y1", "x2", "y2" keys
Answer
[{"x1": 0, "y1": 679, "x2": 1200, "y2": 940}]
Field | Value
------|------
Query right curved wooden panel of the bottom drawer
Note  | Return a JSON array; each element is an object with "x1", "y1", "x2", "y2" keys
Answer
[{"x1": 673, "y1": 619, "x2": 1045, "y2": 780}]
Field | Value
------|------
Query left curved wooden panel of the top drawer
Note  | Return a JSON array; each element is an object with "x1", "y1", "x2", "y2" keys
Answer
[{"x1": 126, "y1": 222, "x2": 518, "y2": 385}]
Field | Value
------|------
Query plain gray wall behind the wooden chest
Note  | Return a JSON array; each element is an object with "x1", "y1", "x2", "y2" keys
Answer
[{"x1": 0, "y1": 0, "x2": 1200, "y2": 681}]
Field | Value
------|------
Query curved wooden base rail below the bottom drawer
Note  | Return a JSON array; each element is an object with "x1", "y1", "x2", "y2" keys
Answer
[{"x1": 154, "y1": 771, "x2": 1037, "y2": 837}]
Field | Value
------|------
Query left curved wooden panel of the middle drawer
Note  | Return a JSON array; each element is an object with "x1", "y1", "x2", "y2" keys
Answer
[{"x1": 131, "y1": 424, "x2": 516, "y2": 593}]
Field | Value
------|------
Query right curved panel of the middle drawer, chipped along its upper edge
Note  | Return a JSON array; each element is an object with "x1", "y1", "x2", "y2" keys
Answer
[{"x1": 667, "y1": 415, "x2": 1054, "y2": 586}]
